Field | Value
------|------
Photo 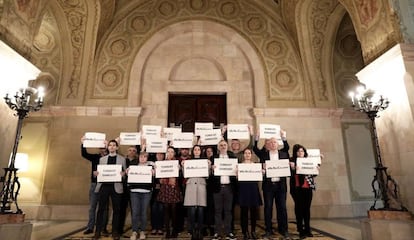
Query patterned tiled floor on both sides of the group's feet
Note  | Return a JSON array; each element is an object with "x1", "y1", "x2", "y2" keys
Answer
[{"x1": 31, "y1": 218, "x2": 362, "y2": 240}]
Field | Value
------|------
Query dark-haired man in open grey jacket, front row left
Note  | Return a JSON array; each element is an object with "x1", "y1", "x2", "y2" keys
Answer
[{"x1": 94, "y1": 140, "x2": 126, "y2": 239}]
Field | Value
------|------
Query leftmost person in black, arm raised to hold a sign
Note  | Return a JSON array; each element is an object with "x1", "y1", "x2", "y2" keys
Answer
[{"x1": 81, "y1": 136, "x2": 108, "y2": 234}]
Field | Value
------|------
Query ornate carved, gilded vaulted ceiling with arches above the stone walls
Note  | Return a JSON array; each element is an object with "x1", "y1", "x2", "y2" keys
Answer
[{"x1": 0, "y1": 0, "x2": 401, "y2": 107}]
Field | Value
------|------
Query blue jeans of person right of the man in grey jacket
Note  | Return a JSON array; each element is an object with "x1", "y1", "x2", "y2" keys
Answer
[{"x1": 131, "y1": 192, "x2": 151, "y2": 232}]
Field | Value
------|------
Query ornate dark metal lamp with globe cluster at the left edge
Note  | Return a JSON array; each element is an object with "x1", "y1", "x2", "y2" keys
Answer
[{"x1": 0, "y1": 87, "x2": 44, "y2": 214}]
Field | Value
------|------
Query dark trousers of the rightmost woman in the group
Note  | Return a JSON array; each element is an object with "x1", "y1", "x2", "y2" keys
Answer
[{"x1": 292, "y1": 188, "x2": 313, "y2": 233}]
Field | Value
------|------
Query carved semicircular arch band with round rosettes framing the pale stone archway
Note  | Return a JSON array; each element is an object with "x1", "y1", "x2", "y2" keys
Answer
[{"x1": 89, "y1": 0, "x2": 306, "y2": 105}]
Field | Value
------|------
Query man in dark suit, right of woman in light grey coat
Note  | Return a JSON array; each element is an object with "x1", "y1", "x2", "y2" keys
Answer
[{"x1": 212, "y1": 140, "x2": 237, "y2": 240}]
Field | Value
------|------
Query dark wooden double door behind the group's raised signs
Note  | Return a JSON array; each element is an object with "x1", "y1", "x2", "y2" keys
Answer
[{"x1": 168, "y1": 94, "x2": 227, "y2": 132}]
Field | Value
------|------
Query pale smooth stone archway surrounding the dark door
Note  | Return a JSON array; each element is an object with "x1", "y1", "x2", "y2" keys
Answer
[{"x1": 128, "y1": 20, "x2": 265, "y2": 126}]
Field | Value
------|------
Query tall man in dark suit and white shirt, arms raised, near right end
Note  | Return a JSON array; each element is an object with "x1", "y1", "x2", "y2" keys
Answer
[{"x1": 253, "y1": 136, "x2": 289, "y2": 238}]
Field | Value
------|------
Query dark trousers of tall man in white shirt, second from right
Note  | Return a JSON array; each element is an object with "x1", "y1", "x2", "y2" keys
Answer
[{"x1": 263, "y1": 182, "x2": 288, "y2": 235}]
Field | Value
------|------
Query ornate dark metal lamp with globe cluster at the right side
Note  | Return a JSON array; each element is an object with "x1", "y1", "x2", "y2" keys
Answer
[{"x1": 349, "y1": 86, "x2": 407, "y2": 211}]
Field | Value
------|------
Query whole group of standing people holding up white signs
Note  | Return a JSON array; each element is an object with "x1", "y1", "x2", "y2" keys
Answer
[{"x1": 81, "y1": 127, "x2": 315, "y2": 240}]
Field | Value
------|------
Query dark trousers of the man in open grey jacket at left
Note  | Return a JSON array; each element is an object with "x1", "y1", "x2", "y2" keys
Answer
[{"x1": 96, "y1": 184, "x2": 121, "y2": 236}]
